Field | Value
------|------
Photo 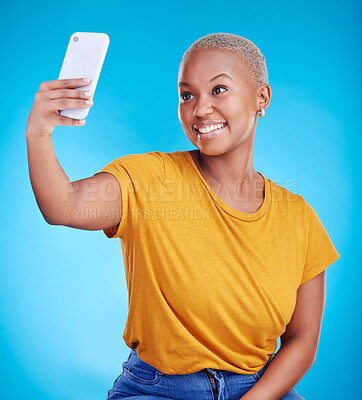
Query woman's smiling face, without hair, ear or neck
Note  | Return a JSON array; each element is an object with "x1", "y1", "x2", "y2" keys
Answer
[{"x1": 178, "y1": 48, "x2": 260, "y2": 155}]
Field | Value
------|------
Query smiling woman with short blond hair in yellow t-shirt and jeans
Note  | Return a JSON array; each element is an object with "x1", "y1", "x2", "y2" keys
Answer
[{"x1": 27, "y1": 33, "x2": 339, "y2": 400}]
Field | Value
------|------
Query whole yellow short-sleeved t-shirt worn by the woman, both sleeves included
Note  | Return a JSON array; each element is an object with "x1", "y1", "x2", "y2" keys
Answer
[{"x1": 92, "y1": 151, "x2": 340, "y2": 374}]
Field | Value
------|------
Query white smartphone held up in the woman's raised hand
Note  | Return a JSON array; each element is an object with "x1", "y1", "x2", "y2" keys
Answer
[{"x1": 58, "y1": 32, "x2": 109, "y2": 119}]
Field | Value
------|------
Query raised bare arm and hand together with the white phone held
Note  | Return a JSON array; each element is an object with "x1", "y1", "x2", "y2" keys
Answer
[{"x1": 26, "y1": 32, "x2": 116, "y2": 230}]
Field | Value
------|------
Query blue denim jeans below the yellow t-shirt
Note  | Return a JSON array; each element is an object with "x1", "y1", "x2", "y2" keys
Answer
[{"x1": 107, "y1": 349, "x2": 304, "y2": 400}]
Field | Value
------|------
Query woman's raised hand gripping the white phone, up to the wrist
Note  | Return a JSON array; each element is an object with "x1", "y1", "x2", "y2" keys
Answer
[{"x1": 26, "y1": 78, "x2": 93, "y2": 137}]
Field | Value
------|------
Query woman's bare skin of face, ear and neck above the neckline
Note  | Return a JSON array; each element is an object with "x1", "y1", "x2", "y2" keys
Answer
[{"x1": 178, "y1": 49, "x2": 271, "y2": 213}]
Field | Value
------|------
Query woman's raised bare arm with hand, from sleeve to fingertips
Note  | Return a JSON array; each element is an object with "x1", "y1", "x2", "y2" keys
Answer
[{"x1": 26, "y1": 79, "x2": 122, "y2": 230}]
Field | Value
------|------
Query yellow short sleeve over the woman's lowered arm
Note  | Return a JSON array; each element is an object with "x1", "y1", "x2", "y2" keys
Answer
[{"x1": 300, "y1": 202, "x2": 340, "y2": 285}]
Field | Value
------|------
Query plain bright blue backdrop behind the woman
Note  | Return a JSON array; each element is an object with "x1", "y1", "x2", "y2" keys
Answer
[{"x1": 0, "y1": 0, "x2": 362, "y2": 400}]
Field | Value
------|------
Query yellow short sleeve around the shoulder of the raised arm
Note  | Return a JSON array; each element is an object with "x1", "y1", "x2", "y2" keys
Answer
[{"x1": 93, "y1": 151, "x2": 164, "y2": 239}]
